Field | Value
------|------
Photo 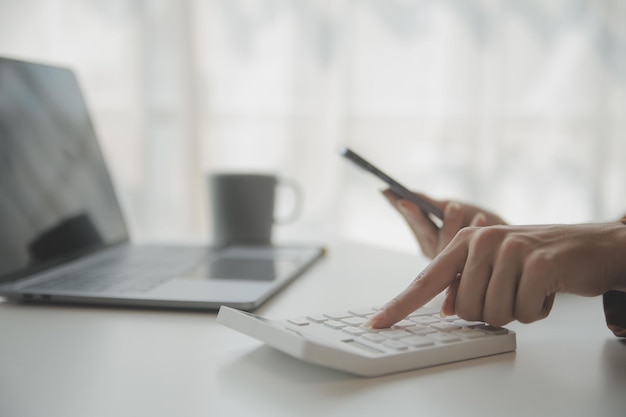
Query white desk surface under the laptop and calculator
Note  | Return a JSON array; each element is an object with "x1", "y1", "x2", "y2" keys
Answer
[{"x1": 0, "y1": 240, "x2": 626, "y2": 417}]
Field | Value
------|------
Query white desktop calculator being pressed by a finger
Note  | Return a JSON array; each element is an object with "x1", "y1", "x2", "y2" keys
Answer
[{"x1": 217, "y1": 307, "x2": 516, "y2": 376}]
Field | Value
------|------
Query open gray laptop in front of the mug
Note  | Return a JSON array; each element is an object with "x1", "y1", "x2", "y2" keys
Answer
[{"x1": 0, "y1": 54, "x2": 324, "y2": 310}]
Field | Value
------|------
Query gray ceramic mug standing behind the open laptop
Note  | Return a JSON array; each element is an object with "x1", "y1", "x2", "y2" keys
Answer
[{"x1": 208, "y1": 173, "x2": 302, "y2": 246}]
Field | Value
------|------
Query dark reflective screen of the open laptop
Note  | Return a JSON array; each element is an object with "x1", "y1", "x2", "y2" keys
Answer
[{"x1": 0, "y1": 58, "x2": 128, "y2": 282}]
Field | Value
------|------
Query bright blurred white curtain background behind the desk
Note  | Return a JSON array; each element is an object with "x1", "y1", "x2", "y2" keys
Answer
[{"x1": 0, "y1": 0, "x2": 626, "y2": 251}]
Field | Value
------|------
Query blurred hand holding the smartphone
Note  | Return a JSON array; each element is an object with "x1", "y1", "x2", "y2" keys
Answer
[{"x1": 383, "y1": 190, "x2": 505, "y2": 259}]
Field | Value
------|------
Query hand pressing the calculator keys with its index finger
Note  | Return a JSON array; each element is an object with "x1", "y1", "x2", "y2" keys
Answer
[{"x1": 368, "y1": 223, "x2": 626, "y2": 328}]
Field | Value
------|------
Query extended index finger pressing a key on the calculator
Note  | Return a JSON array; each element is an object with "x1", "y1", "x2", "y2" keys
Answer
[{"x1": 367, "y1": 239, "x2": 468, "y2": 329}]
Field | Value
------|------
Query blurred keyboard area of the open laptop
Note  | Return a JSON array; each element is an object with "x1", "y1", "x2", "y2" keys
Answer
[{"x1": 24, "y1": 246, "x2": 207, "y2": 294}]
